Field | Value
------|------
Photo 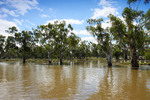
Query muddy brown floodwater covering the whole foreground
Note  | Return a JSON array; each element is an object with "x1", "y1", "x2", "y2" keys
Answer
[{"x1": 0, "y1": 60, "x2": 150, "y2": 100}]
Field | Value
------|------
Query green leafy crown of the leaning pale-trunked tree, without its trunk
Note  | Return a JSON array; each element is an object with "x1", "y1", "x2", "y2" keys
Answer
[{"x1": 86, "y1": 19, "x2": 111, "y2": 54}]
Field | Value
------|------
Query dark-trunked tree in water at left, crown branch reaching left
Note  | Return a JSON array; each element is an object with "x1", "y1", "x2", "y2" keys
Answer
[{"x1": 6, "y1": 26, "x2": 34, "y2": 63}]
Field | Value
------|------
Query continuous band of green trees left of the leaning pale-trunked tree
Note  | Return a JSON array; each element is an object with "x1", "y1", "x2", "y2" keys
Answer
[{"x1": 0, "y1": 21, "x2": 105, "y2": 63}]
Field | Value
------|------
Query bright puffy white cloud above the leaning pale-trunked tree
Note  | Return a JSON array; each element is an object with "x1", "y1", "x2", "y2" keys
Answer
[{"x1": 92, "y1": 7, "x2": 118, "y2": 19}]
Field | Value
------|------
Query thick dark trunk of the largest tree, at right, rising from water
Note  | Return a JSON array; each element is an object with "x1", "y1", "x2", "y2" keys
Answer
[{"x1": 130, "y1": 46, "x2": 139, "y2": 67}]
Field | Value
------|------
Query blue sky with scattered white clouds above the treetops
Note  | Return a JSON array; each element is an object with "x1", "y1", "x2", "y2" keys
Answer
[{"x1": 0, "y1": 0, "x2": 150, "y2": 42}]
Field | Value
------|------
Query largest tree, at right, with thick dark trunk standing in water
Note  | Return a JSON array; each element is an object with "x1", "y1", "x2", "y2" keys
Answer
[{"x1": 109, "y1": 7, "x2": 147, "y2": 67}]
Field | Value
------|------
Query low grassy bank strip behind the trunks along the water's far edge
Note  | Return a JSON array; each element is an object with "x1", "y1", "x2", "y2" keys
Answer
[{"x1": 0, "y1": 57, "x2": 150, "y2": 65}]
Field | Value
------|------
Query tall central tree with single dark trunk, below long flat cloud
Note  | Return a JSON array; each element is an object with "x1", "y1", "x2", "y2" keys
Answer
[{"x1": 54, "y1": 21, "x2": 73, "y2": 65}]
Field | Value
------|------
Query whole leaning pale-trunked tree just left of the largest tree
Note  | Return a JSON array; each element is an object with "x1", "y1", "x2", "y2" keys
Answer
[{"x1": 86, "y1": 18, "x2": 112, "y2": 66}]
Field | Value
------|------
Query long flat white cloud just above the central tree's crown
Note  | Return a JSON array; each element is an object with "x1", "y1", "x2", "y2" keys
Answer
[{"x1": 46, "y1": 19, "x2": 84, "y2": 24}]
